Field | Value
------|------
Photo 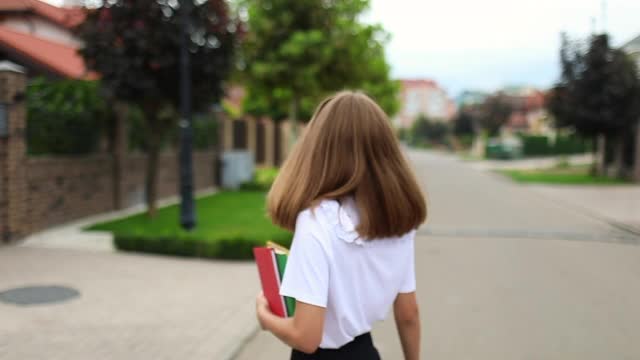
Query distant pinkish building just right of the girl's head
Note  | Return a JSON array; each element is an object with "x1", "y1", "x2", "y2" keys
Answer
[{"x1": 394, "y1": 79, "x2": 455, "y2": 128}]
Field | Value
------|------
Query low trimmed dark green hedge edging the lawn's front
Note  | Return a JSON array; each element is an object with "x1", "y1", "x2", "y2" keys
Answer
[{"x1": 114, "y1": 234, "x2": 292, "y2": 260}]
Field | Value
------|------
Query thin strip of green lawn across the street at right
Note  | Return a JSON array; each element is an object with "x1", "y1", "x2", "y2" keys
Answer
[{"x1": 498, "y1": 166, "x2": 627, "y2": 185}]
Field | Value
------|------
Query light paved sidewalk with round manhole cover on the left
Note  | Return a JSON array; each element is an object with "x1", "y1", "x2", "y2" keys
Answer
[{"x1": 0, "y1": 189, "x2": 260, "y2": 360}]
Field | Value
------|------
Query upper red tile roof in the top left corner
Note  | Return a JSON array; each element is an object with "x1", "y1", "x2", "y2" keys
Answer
[{"x1": 0, "y1": 0, "x2": 86, "y2": 28}]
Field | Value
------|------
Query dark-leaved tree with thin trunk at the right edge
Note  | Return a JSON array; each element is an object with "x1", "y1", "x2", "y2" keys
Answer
[{"x1": 547, "y1": 34, "x2": 640, "y2": 174}]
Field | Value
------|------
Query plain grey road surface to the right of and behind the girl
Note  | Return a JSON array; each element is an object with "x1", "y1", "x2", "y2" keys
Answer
[{"x1": 236, "y1": 152, "x2": 640, "y2": 360}]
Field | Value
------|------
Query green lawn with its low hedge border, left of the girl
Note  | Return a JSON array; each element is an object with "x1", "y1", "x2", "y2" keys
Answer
[{"x1": 86, "y1": 191, "x2": 292, "y2": 259}]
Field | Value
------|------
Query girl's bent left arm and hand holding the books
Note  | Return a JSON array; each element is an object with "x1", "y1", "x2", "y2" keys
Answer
[{"x1": 256, "y1": 293, "x2": 325, "y2": 354}]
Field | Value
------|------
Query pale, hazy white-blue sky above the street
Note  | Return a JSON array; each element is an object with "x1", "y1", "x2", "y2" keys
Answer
[{"x1": 47, "y1": 0, "x2": 640, "y2": 95}]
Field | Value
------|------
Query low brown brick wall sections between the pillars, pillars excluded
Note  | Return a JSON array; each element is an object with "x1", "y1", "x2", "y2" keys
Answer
[{"x1": 24, "y1": 151, "x2": 215, "y2": 233}]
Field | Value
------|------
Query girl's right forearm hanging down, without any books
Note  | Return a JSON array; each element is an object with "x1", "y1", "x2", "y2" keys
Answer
[{"x1": 393, "y1": 292, "x2": 420, "y2": 360}]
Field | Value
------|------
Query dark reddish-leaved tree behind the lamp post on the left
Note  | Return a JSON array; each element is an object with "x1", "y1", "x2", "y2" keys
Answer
[{"x1": 79, "y1": 0, "x2": 239, "y2": 216}]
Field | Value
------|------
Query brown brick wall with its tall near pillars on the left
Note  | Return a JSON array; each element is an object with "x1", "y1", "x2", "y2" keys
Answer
[{"x1": 0, "y1": 62, "x2": 216, "y2": 242}]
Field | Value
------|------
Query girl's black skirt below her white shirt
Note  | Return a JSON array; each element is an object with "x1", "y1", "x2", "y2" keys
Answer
[{"x1": 291, "y1": 333, "x2": 380, "y2": 360}]
